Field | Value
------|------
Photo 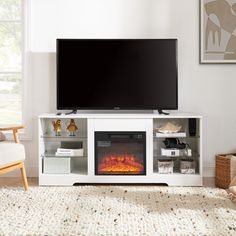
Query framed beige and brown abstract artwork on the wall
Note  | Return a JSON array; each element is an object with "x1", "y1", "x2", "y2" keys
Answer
[{"x1": 200, "y1": 0, "x2": 236, "y2": 63}]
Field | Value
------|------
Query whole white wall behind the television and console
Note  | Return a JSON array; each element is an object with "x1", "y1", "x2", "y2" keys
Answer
[{"x1": 6, "y1": 0, "x2": 236, "y2": 176}]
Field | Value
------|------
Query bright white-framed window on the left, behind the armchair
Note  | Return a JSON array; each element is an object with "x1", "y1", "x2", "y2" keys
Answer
[{"x1": 0, "y1": 0, "x2": 23, "y2": 125}]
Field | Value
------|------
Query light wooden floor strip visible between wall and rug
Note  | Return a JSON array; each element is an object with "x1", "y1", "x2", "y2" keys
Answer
[{"x1": 0, "y1": 177, "x2": 215, "y2": 187}]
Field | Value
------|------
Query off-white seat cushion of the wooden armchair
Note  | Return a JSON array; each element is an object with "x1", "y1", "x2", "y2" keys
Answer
[{"x1": 0, "y1": 142, "x2": 25, "y2": 167}]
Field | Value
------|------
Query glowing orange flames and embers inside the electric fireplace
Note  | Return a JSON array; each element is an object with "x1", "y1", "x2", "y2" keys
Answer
[{"x1": 98, "y1": 154, "x2": 144, "y2": 174}]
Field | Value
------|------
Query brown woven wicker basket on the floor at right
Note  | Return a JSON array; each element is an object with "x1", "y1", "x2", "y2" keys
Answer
[{"x1": 215, "y1": 153, "x2": 236, "y2": 189}]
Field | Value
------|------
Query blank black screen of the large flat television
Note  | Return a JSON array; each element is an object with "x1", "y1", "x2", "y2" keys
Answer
[{"x1": 57, "y1": 39, "x2": 178, "y2": 110}]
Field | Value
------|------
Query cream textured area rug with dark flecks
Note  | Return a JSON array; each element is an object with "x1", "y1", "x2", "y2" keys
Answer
[{"x1": 0, "y1": 186, "x2": 236, "y2": 236}]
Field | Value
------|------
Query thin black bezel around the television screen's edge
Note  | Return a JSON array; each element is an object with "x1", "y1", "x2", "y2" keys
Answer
[{"x1": 56, "y1": 38, "x2": 178, "y2": 110}]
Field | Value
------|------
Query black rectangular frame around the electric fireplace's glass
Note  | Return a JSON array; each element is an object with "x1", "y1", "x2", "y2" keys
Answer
[{"x1": 94, "y1": 131, "x2": 147, "y2": 176}]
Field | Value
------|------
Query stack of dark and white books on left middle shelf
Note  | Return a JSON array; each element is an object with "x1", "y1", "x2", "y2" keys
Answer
[{"x1": 55, "y1": 141, "x2": 84, "y2": 157}]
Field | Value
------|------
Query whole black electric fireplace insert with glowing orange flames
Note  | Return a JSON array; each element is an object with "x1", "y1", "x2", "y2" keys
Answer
[{"x1": 95, "y1": 131, "x2": 146, "y2": 175}]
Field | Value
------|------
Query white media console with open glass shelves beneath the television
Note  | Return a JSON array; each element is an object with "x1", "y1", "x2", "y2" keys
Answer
[{"x1": 38, "y1": 113, "x2": 202, "y2": 186}]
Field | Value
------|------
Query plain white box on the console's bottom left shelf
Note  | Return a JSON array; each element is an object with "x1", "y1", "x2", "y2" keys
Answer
[{"x1": 43, "y1": 157, "x2": 71, "y2": 174}]
